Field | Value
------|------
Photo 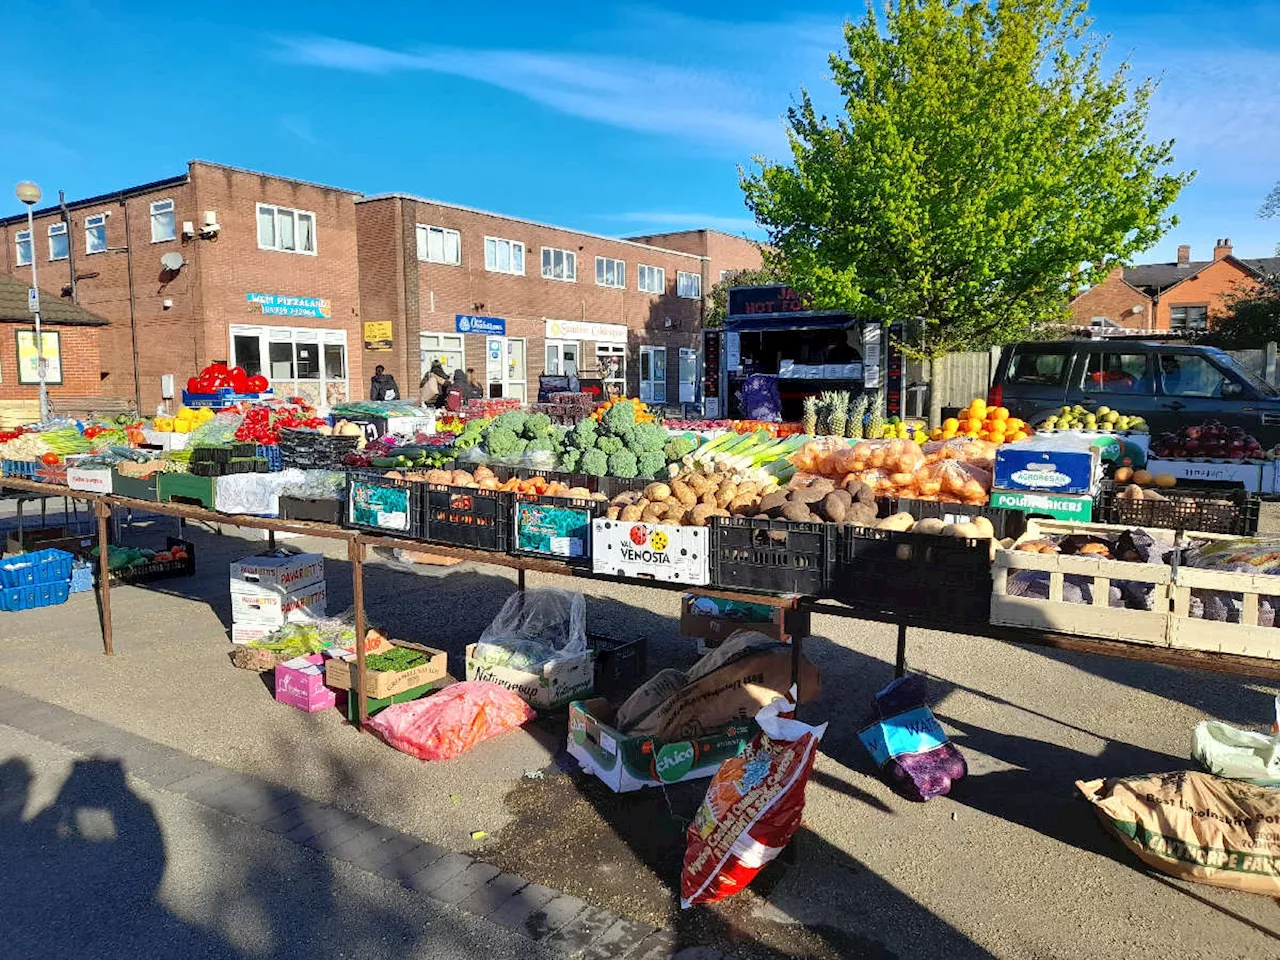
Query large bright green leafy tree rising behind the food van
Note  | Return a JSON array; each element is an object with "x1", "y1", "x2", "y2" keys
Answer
[{"x1": 742, "y1": 0, "x2": 1193, "y2": 357}]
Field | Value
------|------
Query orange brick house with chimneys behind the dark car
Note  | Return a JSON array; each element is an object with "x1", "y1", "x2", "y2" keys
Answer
[{"x1": 1071, "y1": 239, "x2": 1280, "y2": 332}]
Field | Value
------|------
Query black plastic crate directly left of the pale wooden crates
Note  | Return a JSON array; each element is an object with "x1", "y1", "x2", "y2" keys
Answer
[{"x1": 827, "y1": 526, "x2": 991, "y2": 623}]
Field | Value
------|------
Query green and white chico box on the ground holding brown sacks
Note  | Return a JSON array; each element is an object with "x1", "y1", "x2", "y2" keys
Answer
[{"x1": 568, "y1": 699, "x2": 759, "y2": 794}]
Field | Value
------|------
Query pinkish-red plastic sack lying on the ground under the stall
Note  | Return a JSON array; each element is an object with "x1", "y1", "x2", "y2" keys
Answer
[{"x1": 369, "y1": 681, "x2": 538, "y2": 760}]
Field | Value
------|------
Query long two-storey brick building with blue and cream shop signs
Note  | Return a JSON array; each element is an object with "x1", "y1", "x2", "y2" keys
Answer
[{"x1": 356, "y1": 193, "x2": 759, "y2": 404}]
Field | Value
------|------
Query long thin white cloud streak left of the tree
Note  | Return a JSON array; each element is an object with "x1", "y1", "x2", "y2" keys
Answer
[{"x1": 279, "y1": 37, "x2": 785, "y2": 152}]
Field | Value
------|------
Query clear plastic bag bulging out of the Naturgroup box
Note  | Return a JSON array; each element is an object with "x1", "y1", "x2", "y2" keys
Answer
[{"x1": 475, "y1": 590, "x2": 586, "y2": 671}]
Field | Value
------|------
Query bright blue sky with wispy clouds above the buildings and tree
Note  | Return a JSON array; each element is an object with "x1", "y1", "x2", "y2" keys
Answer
[{"x1": 0, "y1": 0, "x2": 1280, "y2": 260}]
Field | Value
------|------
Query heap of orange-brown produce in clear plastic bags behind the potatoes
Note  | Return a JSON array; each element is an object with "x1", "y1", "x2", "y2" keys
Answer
[{"x1": 791, "y1": 438, "x2": 996, "y2": 504}]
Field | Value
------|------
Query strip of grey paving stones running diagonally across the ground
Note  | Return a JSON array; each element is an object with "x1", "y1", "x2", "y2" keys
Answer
[{"x1": 0, "y1": 686, "x2": 721, "y2": 960}]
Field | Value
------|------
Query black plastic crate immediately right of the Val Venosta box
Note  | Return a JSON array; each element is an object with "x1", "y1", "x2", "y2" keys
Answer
[{"x1": 710, "y1": 517, "x2": 836, "y2": 596}]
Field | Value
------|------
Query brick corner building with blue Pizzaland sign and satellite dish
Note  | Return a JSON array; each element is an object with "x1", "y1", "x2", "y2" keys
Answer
[{"x1": 0, "y1": 161, "x2": 364, "y2": 412}]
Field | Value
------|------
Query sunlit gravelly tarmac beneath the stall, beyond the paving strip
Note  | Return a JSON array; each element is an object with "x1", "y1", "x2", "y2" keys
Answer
[{"x1": 0, "y1": 506, "x2": 1280, "y2": 959}]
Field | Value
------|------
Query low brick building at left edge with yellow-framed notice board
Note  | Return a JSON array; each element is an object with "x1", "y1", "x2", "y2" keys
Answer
[{"x1": 0, "y1": 276, "x2": 108, "y2": 428}]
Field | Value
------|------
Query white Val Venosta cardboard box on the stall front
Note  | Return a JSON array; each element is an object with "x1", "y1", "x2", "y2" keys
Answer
[{"x1": 591, "y1": 520, "x2": 712, "y2": 586}]
